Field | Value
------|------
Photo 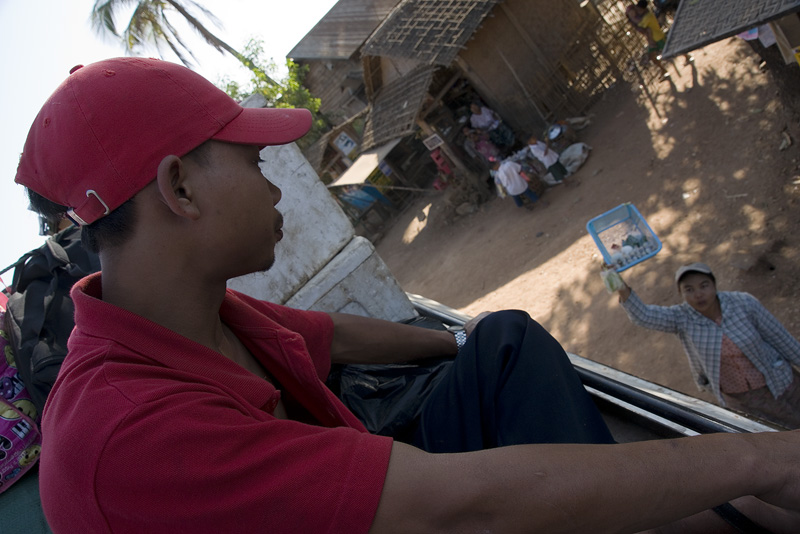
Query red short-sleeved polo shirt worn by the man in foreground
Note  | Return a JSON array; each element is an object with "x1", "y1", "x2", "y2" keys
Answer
[{"x1": 40, "y1": 273, "x2": 392, "y2": 533}]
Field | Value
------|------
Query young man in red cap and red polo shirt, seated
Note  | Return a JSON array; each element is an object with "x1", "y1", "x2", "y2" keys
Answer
[{"x1": 16, "y1": 58, "x2": 800, "y2": 533}]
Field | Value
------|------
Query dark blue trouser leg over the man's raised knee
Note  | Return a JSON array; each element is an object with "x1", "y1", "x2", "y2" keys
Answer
[{"x1": 412, "y1": 310, "x2": 614, "y2": 453}]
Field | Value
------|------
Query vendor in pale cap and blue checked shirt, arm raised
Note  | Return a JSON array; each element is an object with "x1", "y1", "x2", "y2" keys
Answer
[{"x1": 619, "y1": 263, "x2": 800, "y2": 428}]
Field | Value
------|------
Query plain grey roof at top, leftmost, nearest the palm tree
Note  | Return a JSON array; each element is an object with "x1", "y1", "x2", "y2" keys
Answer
[{"x1": 286, "y1": 0, "x2": 398, "y2": 60}]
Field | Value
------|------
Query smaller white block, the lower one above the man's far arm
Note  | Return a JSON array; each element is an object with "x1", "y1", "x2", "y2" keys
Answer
[{"x1": 286, "y1": 237, "x2": 417, "y2": 321}]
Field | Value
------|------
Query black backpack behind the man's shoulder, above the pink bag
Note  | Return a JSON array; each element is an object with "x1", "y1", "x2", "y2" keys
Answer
[{"x1": 5, "y1": 226, "x2": 100, "y2": 414}]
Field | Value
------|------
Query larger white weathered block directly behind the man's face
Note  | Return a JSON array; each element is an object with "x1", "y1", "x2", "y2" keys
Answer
[{"x1": 228, "y1": 143, "x2": 354, "y2": 304}]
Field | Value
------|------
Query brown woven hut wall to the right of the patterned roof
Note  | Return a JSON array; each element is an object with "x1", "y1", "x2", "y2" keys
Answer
[{"x1": 458, "y1": 0, "x2": 619, "y2": 135}]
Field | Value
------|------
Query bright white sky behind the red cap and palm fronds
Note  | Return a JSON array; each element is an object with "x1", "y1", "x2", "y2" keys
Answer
[{"x1": 0, "y1": 0, "x2": 336, "y2": 284}]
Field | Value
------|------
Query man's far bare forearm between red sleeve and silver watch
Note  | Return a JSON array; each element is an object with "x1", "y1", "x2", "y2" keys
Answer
[{"x1": 330, "y1": 313, "x2": 458, "y2": 363}]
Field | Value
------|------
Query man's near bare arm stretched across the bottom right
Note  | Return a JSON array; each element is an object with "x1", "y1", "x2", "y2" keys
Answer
[{"x1": 370, "y1": 432, "x2": 800, "y2": 534}]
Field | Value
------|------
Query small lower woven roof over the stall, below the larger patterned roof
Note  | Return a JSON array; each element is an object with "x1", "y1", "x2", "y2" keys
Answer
[{"x1": 361, "y1": 65, "x2": 436, "y2": 150}]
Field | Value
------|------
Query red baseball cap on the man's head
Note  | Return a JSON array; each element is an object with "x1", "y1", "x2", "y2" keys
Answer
[{"x1": 15, "y1": 58, "x2": 311, "y2": 224}]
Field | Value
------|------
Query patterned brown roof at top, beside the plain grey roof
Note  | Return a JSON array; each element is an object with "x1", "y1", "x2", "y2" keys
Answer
[{"x1": 363, "y1": 0, "x2": 498, "y2": 66}]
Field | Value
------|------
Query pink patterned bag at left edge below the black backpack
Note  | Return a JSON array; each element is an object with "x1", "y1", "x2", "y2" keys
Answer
[{"x1": 0, "y1": 308, "x2": 42, "y2": 493}]
